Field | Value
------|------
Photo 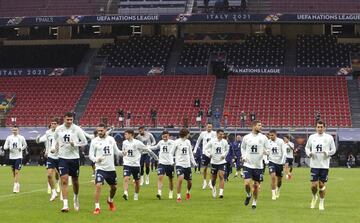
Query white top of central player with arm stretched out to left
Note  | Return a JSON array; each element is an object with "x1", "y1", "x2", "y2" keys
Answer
[{"x1": 149, "y1": 139, "x2": 175, "y2": 165}]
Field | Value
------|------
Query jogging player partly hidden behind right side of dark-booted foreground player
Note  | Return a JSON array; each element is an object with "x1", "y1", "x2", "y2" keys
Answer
[{"x1": 269, "y1": 130, "x2": 286, "y2": 200}]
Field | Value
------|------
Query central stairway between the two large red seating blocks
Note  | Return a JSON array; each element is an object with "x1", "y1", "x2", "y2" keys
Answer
[{"x1": 211, "y1": 79, "x2": 227, "y2": 123}]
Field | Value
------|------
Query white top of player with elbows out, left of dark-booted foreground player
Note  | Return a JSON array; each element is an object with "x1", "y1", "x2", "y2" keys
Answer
[{"x1": 204, "y1": 138, "x2": 229, "y2": 165}]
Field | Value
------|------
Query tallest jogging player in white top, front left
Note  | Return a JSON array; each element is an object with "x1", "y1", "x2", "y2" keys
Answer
[{"x1": 50, "y1": 112, "x2": 87, "y2": 212}]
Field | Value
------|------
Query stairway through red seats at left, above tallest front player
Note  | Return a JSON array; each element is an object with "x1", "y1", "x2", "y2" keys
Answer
[{"x1": 75, "y1": 78, "x2": 99, "y2": 123}]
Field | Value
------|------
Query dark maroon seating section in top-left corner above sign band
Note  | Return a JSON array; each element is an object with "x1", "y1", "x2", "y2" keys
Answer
[{"x1": 0, "y1": 0, "x2": 108, "y2": 17}]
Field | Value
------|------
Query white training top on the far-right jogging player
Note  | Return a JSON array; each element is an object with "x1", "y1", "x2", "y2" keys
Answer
[{"x1": 305, "y1": 133, "x2": 336, "y2": 169}]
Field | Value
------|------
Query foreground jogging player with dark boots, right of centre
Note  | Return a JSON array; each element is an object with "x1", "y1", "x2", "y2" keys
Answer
[{"x1": 241, "y1": 120, "x2": 270, "y2": 209}]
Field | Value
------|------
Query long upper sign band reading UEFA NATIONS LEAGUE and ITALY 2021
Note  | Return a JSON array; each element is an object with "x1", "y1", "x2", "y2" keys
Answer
[{"x1": 0, "y1": 13, "x2": 360, "y2": 27}]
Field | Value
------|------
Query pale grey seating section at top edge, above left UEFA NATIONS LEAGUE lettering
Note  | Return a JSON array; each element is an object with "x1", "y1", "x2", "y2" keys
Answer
[{"x1": 118, "y1": 0, "x2": 186, "y2": 15}]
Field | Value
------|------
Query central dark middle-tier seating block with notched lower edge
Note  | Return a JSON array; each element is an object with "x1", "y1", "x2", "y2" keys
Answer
[{"x1": 178, "y1": 35, "x2": 286, "y2": 67}]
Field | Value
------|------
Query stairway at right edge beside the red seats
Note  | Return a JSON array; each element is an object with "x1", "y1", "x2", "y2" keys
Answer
[{"x1": 347, "y1": 80, "x2": 360, "y2": 128}]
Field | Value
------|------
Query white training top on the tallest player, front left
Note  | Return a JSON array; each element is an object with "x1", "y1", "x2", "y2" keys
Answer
[{"x1": 51, "y1": 124, "x2": 87, "y2": 159}]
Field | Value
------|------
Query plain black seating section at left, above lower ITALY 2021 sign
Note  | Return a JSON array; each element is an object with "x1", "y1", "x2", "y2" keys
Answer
[{"x1": 0, "y1": 45, "x2": 89, "y2": 68}]
